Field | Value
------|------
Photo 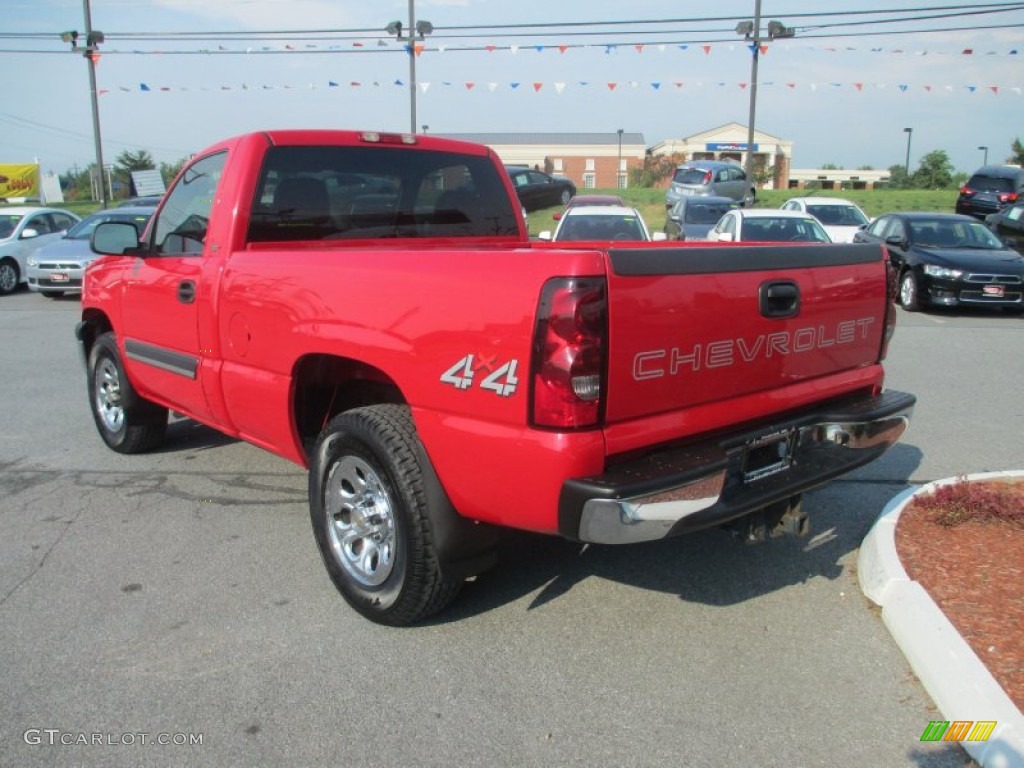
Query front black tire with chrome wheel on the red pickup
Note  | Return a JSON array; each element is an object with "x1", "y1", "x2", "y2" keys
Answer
[{"x1": 88, "y1": 333, "x2": 167, "y2": 454}]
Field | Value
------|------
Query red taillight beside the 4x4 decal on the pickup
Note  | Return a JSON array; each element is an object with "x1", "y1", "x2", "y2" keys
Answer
[{"x1": 530, "y1": 278, "x2": 608, "y2": 429}]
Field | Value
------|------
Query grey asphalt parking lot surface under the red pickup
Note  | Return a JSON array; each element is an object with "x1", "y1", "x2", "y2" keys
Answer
[{"x1": 0, "y1": 292, "x2": 1024, "y2": 768}]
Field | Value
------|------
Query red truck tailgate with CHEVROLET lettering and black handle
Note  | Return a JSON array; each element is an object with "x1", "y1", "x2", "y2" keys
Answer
[{"x1": 605, "y1": 244, "x2": 887, "y2": 424}]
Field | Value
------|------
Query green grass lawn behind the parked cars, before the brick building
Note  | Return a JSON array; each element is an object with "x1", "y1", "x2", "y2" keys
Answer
[{"x1": 527, "y1": 188, "x2": 956, "y2": 236}]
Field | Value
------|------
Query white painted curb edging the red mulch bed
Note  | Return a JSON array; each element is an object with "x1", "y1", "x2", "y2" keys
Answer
[{"x1": 857, "y1": 470, "x2": 1024, "y2": 768}]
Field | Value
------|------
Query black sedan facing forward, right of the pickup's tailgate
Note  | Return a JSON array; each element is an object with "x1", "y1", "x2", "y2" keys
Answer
[{"x1": 854, "y1": 213, "x2": 1024, "y2": 312}]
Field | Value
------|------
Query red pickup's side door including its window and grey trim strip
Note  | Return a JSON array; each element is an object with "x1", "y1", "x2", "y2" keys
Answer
[{"x1": 121, "y1": 152, "x2": 227, "y2": 418}]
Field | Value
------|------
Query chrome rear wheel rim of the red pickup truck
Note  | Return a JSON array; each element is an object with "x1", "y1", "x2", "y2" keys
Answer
[{"x1": 324, "y1": 456, "x2": 395, "y2": 587}]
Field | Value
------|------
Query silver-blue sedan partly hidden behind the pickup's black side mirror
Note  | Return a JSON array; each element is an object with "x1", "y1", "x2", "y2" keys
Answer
[{"x1": 27, "y1": 206, "x2": 157, "y2": 298}]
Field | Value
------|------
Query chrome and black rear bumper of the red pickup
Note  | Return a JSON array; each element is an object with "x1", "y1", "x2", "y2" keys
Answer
[{"x1": 559, "y1": 391, "x2": 915, "y2": 544}]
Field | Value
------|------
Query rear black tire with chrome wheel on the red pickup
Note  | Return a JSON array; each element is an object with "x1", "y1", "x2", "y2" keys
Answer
[{"x1": 309, "y1": 404, "x2": 463, "y2": 627}]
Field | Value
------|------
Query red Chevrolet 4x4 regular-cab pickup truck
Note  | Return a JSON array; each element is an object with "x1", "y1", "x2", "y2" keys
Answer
[{"x1": 76, "y1": 130, "x2": 914, "y2": 625}]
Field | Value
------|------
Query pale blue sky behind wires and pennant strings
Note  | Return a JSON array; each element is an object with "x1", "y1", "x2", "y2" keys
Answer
[{"x1": 0, "y1": 0, "x2": 1024, "y2": 172}]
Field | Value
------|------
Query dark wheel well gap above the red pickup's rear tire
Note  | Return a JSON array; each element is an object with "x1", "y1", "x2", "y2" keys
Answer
[{"x1": 292, "y1": 354, "x2": 406, "y2": 456}]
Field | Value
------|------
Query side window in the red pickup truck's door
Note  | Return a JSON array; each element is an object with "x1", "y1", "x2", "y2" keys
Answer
[{"x1": 152, "y1": 152, "x2": 227, "y2": 255}]
